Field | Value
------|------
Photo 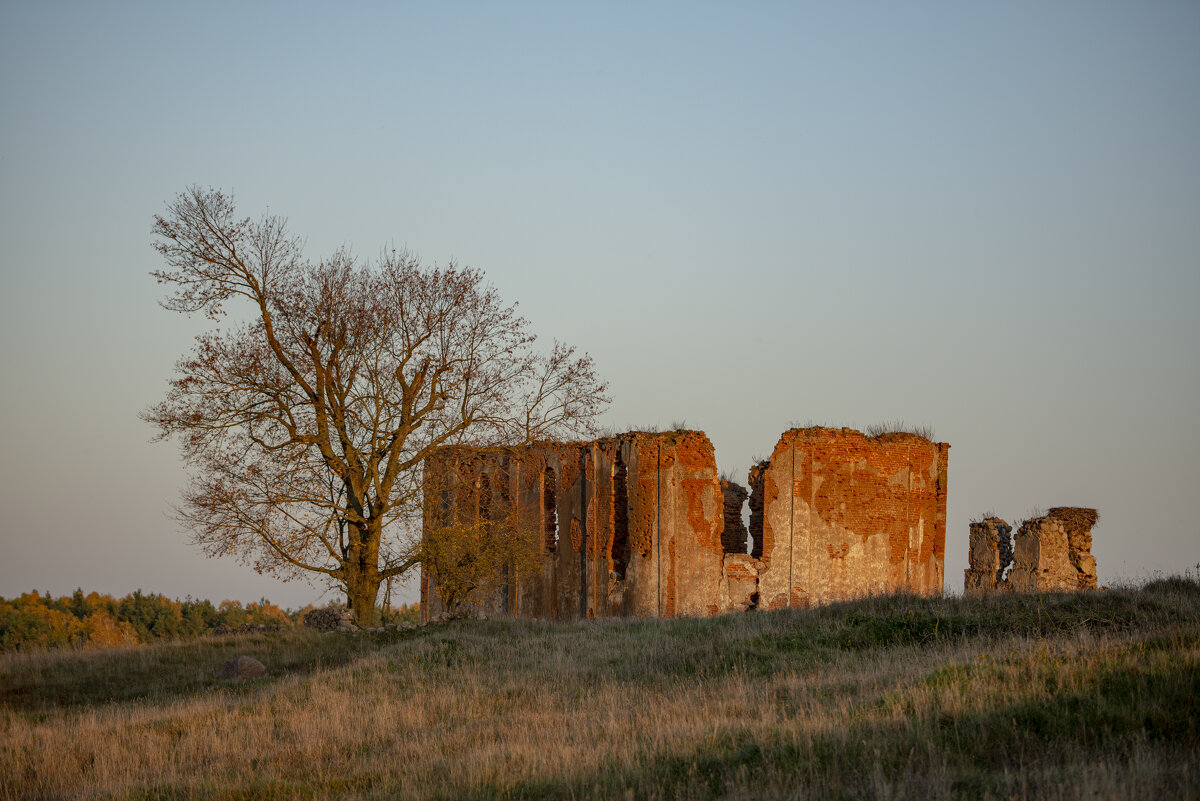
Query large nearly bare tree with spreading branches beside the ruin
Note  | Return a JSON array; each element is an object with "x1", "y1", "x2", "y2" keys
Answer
[{"x1": 143, "y1": 187, "x2": 608, "y2": 625}]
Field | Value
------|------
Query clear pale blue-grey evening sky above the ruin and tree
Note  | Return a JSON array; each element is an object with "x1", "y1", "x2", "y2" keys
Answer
[{"x1": 0, "y1": 0, "x2": 1200, "y2": 608}]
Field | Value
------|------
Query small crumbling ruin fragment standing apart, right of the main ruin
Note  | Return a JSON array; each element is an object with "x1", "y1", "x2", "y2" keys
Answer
[{"x1": 964, "y1": 506, "x2": 1099, "y2": 597}]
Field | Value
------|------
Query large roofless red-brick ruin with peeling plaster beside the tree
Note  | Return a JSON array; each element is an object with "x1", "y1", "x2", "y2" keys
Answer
[{"x1": 421, "y1": 427, "x2": 949, "y2": 621}]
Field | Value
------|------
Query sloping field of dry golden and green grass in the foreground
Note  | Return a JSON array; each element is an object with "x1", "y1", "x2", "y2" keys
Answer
[{"x1": 0, "y1": 579, "x2": 1200, "y2": 801}]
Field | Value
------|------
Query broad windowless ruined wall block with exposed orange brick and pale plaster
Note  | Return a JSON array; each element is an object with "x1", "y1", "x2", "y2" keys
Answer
[{"x1": 750, "y1": 427, "x2": 950, "y2": 609}]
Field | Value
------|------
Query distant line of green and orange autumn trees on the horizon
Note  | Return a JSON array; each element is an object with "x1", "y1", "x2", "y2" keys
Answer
[{"x1": 0, "y1": 589, "x2": 415, "y2": 651}]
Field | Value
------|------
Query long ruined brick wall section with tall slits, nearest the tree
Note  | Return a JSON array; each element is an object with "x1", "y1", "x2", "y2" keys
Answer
[{"x1": 421, "y1": 430, "x2": 730, "y2": 620}]
